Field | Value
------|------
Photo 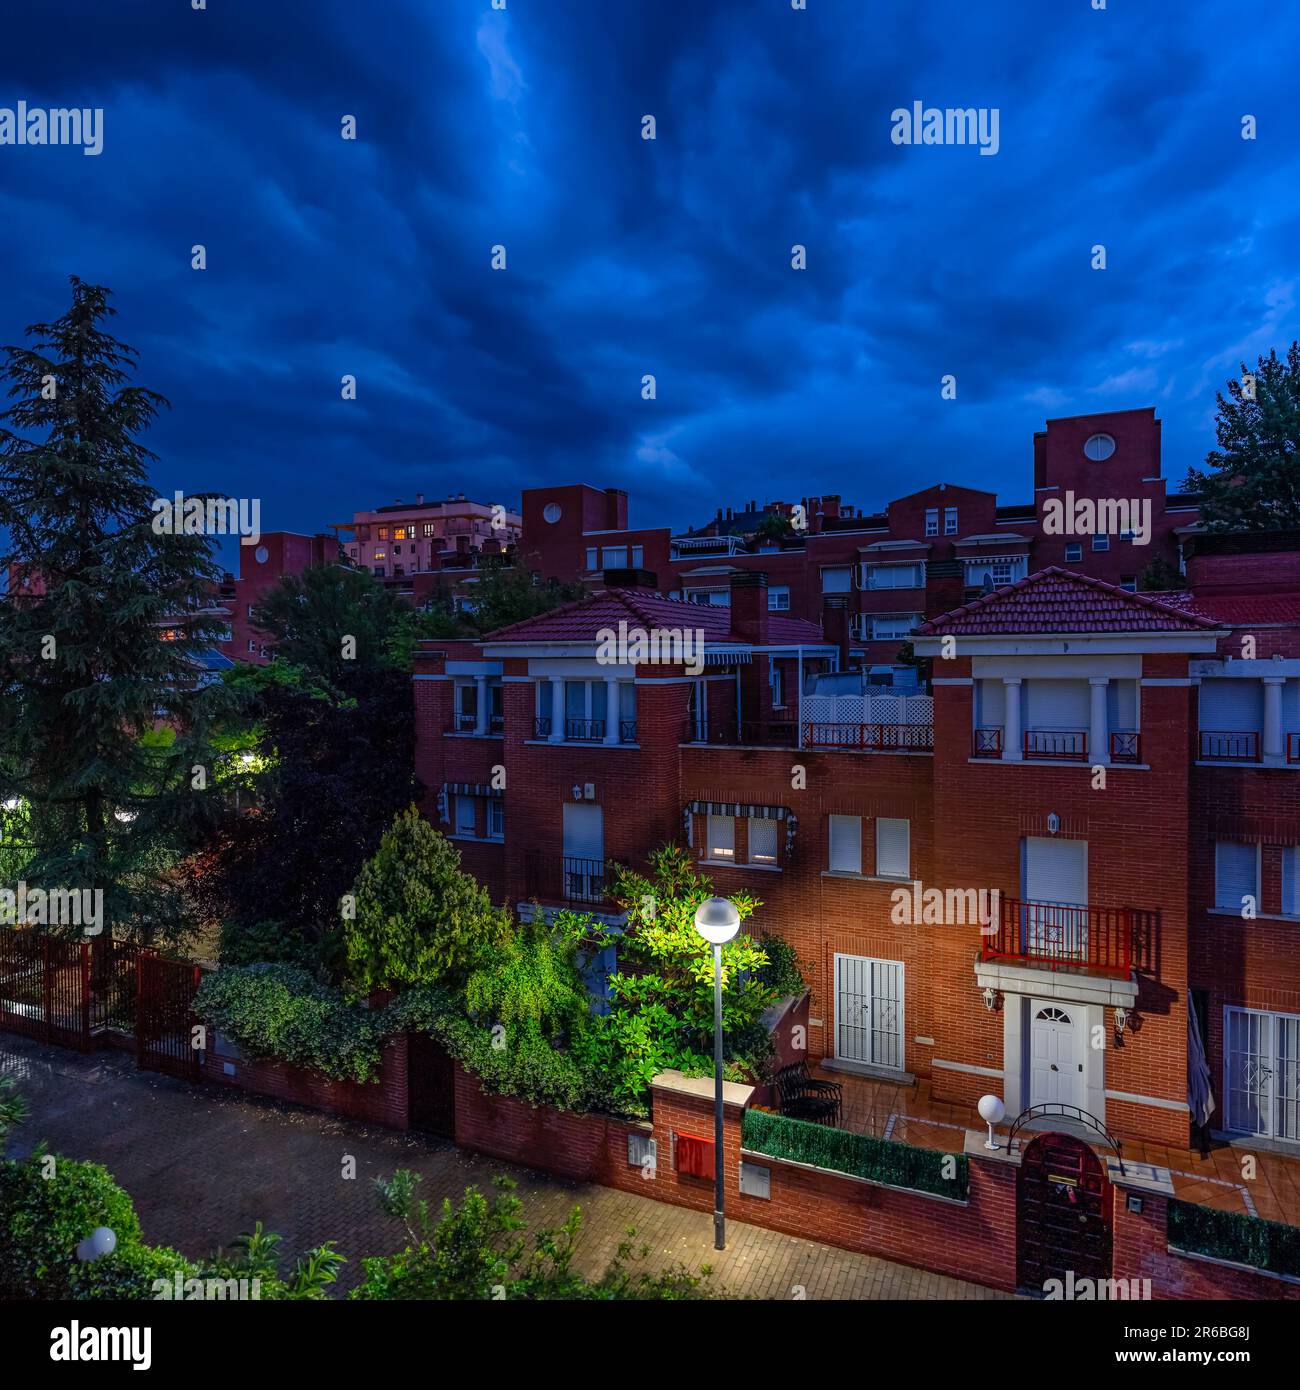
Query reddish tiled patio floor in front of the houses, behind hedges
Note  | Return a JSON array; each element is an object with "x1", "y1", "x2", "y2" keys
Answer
[{"x1": 815, "y1": 1068, "x2": 1300, "y2": 1226}]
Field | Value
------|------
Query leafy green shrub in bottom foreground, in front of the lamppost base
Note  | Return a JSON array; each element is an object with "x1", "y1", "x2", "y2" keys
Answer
[{"x1": 350, "y1": 1169, "x2": 712, "y2": 1301}]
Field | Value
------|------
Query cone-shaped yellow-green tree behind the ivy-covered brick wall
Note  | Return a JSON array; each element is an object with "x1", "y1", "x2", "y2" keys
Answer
[{"x1": 343, "y1": 806, "x2": 509, "y2": 990}]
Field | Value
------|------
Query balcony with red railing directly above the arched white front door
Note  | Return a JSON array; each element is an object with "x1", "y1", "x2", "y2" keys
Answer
[{"x1": 980, "y1": 898, "x2": 1155, "y2": 976}]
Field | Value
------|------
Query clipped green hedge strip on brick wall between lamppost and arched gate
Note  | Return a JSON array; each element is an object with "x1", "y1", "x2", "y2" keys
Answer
[{"x1": 741, "y1": 1111, "x2": 970, "y2": 1201}]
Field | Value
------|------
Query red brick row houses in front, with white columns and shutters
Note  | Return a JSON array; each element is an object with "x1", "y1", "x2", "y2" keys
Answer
[{"x1": 414, "y1": 536, "x2": 1300, "y2": 1147}]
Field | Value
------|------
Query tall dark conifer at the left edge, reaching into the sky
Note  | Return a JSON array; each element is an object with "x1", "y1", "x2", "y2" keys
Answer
[{"x1": 0, "y1": 277, "x2": 224, "y2": 938}]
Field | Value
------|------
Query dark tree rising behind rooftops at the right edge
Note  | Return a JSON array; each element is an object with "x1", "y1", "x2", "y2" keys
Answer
[{"x1": 1185, "y1": 342, "x2": 1300, "y2": 531}]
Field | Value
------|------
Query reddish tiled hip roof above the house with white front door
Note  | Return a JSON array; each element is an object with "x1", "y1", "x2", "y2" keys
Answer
[{"x1": 916, "y1": 566, "x2": 1218, "y2": 637}]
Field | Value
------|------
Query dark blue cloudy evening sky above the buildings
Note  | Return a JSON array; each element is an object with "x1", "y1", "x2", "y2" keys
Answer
[{"x1": 0, "y1": 0, "x2": 1300, "y2": 558}]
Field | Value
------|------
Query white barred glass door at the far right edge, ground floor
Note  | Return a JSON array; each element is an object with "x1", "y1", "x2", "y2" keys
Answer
[{"x1": 1224, "y1": 1009, "x2": 1300, "y2": 1140}]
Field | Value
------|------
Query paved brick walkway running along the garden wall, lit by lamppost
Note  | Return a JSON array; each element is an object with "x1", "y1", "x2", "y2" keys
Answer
[{"x1": 0, "y1": 1034, "x2": 1007, "y2": 1298}]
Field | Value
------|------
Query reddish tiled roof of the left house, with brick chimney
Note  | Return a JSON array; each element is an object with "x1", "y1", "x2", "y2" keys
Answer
[{"x1": 484, "y1": 589, "x2": 826, "y2": 646}]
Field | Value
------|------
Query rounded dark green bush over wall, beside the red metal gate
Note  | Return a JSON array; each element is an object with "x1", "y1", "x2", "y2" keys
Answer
[{"x1": 195, "y1": 963, "x2": 387, "y2": 1081}]
